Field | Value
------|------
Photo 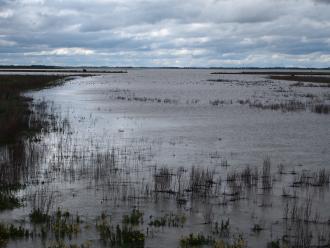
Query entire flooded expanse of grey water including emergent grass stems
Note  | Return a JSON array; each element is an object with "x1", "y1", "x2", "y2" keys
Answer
[{"x1": 0, "y1": 69, "x2": 330, "y2": 248}]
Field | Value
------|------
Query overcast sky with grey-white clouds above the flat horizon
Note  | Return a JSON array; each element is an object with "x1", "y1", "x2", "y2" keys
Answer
[{"x1": 0, "y1": 0, "x2": 330, "y2": 67}]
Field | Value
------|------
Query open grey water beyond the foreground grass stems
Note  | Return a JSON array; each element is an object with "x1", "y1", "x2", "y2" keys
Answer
[{"x1": 33, "y1": 70, "x2": 330, "y2": 166}]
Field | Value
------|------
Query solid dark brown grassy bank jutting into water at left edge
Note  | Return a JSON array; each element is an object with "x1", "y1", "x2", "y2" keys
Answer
[{"x1": 0, "y1": 75, "x2": 64, "y2": 146}]
